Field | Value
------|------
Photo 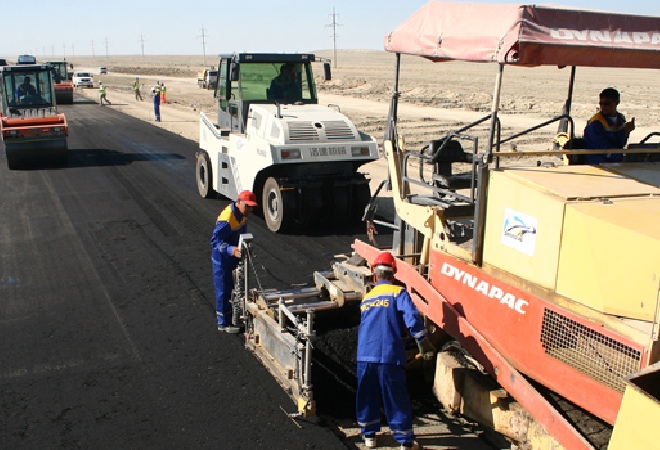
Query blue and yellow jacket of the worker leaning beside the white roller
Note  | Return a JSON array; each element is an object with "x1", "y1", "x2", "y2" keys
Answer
[{"x1": 211, "y1": 202, "x2": 247, "y2": 270}]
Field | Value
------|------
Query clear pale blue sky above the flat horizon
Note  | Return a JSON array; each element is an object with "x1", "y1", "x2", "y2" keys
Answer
[{"x1": 5, "y1": 0, "x2": 660, "y2": 57}]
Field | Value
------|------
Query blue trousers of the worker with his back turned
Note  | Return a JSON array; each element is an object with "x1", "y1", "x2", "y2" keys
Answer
[{"x1": 356, "y1": 361, "x2": 415, "y2": 444}]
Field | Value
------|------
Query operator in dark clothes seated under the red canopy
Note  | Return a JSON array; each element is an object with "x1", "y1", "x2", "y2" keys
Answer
[{"x1": 584, "y1": 87, "x2": 635, "y2": 165}]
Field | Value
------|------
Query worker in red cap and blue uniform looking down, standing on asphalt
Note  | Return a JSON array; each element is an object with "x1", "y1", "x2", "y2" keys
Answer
[{"x1": 211, "y1": 191, "x2": 257, "y2": 333}]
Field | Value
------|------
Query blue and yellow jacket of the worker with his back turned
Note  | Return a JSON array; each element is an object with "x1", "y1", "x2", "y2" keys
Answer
[{"x1": 357, "y1": 280, "x2": 427, "y2": 366}]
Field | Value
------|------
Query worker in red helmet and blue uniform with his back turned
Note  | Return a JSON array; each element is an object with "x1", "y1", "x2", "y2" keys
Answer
[{"x1": 356, "y1": 252, "x2": 434, "y2": 449}]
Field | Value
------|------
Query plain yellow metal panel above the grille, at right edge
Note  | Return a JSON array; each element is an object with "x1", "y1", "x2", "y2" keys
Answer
[{"x1": 557, "y1": 198, "x2": 660, "y2": 321}]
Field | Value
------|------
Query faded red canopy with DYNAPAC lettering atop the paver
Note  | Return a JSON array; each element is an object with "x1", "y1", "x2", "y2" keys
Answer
[{"x1": 385, "y1": 1, "x2": 660, "y2": 69}]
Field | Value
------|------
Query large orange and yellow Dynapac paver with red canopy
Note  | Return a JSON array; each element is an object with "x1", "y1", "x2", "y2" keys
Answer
[{"x1": 226, "y1": 1, "x2": 660, "y2": 450}]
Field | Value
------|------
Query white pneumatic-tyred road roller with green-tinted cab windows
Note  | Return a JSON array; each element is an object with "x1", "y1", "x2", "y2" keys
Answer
[{"x1": 195, "y1": 53, "x2": 379, "y2": 232}]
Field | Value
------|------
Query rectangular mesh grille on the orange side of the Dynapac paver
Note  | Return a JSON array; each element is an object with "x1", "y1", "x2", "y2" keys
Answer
[{"x1": 541, "y1": 309, "x2": 641, "y2": 392}]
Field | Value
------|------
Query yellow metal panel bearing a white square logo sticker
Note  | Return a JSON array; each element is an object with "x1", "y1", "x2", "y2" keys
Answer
[{"x1": 484, "y1": 170, "x2": 564, "y2": 289}]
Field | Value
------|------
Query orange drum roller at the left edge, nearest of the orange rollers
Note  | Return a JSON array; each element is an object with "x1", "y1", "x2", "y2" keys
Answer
[{"x1": 0, "y1": 64, "x2": 69, "y2": 170}]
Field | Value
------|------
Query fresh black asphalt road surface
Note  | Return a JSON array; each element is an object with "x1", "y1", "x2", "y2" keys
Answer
[{"x1": 0, "y1": 98, "x2": 361, "y2": 450}]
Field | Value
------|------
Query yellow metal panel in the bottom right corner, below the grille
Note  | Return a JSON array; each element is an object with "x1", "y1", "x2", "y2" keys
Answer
[{"x1": 607, "y1": 363, "x2": 660, "y2": 450}]
